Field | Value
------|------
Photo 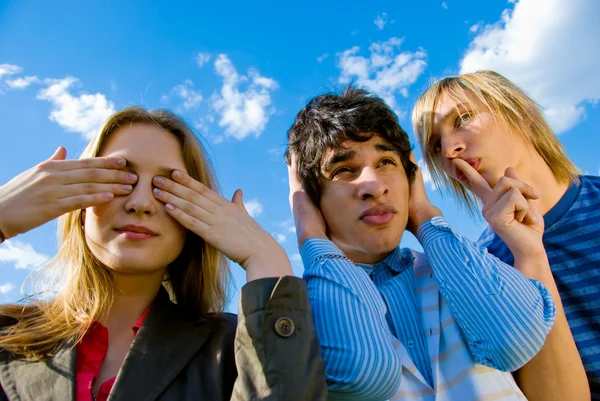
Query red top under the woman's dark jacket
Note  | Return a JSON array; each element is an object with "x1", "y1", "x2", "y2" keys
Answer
[{"x1": 75, "y1": 309, "x2": 149, "y2": 401}]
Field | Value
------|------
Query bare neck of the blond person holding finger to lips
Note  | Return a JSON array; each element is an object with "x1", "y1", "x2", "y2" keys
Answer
[{"x1": 517, "y1": 149, "x2": 569, "y2": 215}]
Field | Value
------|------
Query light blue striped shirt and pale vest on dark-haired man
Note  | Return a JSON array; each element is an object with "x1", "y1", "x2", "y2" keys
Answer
[{"x1": 301, "y1": 217, "x2": 555, "y2": 401}]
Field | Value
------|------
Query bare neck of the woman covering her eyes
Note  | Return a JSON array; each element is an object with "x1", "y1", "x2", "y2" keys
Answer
[{"x1": 100, "y1": 272, "x2": 163, "y2": 333}]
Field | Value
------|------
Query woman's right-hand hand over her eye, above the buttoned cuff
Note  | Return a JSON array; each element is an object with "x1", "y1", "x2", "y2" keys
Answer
[{"x1": 154, "y1": 170, "x2": 292, "y2": 281}]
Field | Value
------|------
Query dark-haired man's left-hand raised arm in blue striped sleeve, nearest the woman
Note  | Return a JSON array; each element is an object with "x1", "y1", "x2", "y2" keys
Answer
[{"x1": 290, "y1": 160, "x2": 402, "y2": 400}]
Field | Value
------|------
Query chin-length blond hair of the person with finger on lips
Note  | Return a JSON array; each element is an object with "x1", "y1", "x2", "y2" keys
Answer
[{"x1": 412, "y1": 71, "x2": 580, "y2": 212}]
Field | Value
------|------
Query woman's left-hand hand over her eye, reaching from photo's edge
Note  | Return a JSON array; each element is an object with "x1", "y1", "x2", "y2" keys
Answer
[{"x1": 0, "y1": 147, "x2": 137, "y2": 239}]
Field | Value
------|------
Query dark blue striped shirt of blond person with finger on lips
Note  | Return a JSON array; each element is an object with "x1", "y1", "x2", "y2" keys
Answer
[{"x1": 480, "y1": 176, "x2": 600, "y2": 400}]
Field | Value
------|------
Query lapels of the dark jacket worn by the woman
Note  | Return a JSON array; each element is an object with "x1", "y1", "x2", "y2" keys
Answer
[{"x1": 0, "y1": 288, "x2": 216, "y2": 401}]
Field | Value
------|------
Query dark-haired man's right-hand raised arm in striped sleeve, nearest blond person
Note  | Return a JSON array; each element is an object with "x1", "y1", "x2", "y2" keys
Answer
[{"x1": 410, "y1": 158, "x2": 555, "y2": 371}]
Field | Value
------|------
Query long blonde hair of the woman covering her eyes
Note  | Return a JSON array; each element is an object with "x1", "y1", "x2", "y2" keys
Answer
[{"x1": 0, "y1": 107, "x2": 230, "y2": 359}]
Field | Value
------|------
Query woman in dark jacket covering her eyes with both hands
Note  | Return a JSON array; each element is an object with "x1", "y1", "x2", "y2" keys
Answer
[{"x1": 0, "y1": 107, "x2": 326, "y2": 401}]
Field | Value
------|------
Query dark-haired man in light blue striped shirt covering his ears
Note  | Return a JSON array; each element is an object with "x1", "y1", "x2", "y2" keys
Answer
[{"x1": 286, "y1": 87, "x2": 555, "y2": 400}]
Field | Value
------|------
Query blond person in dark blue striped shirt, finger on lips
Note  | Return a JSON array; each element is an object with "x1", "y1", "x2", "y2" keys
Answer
[{"x1": 413, "y1": 71, "x2": 600, "y2": 401}]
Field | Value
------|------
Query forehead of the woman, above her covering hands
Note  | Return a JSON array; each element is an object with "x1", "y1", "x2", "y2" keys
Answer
[{"x1": 100, "y1": 124, "x2": 185, "y2": 169}]
